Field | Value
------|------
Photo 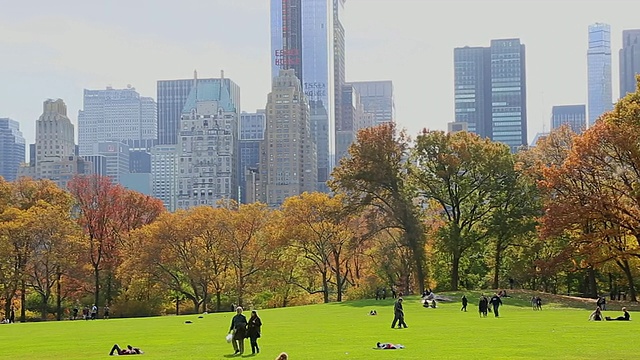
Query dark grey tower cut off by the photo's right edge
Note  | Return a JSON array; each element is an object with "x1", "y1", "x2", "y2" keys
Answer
[{"x1": 620, "y1": 29, "x2": 640, "y2": 97}]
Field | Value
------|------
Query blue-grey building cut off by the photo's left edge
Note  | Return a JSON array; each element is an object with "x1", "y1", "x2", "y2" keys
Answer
[{"x1": 0, "y1": 118, "x2": 26, "y2": 181}]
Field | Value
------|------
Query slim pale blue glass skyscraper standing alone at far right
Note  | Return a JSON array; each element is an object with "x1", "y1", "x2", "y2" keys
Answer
[{"x1": 587, "y1": 23, "x2": 613, "y2": 126}]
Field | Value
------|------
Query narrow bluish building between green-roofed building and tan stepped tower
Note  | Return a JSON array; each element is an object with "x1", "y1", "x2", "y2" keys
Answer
[{"x1": 239, "y1": 110, "x2": 266, "y2": 204}]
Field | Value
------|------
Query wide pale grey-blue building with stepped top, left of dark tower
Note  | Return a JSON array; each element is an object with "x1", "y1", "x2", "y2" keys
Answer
[{"x1": 78, "y1": 87, "x2": 158, "y2": 156}]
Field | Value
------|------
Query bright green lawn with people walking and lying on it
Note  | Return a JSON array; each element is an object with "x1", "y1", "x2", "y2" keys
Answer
[{"x1": 0, "y1": 293, "x2": 640, "y2": 360}]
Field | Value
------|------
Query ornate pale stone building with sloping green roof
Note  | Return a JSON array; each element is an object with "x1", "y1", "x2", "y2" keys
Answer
[{"x1": 177, "y1": 78, "x2": 240, "y2": 209}]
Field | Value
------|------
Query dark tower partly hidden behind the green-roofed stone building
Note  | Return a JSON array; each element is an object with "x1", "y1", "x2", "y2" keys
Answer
[{"x1": 157, "y1": 71, "x2": 240, "y2": 145}]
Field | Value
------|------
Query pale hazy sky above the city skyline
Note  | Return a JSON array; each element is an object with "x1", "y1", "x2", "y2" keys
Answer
[{"x1": 0, "y1": 0, "x2": 640, "y2": 148}]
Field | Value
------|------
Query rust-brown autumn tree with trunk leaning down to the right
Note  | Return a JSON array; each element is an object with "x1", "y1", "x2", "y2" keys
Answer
[{"x1": 329, "y1": 123, "x2": 426, "y2": 292}]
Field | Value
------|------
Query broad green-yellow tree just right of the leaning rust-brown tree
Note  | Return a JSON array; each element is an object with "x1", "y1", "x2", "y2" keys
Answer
[{"x1": 410, "y1": 130, "x2": 514, "y2": 290}]
